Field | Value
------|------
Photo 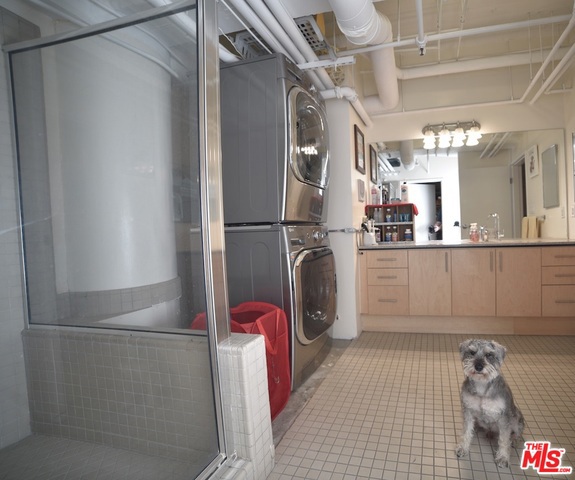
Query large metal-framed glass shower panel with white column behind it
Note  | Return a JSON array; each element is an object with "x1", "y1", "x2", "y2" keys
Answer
[{"x1": 8, "y1": 1, "x2": 227, "y2": 478}]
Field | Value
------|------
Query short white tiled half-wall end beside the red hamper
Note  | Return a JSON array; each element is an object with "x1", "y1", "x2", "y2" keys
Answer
[{"x1": 219, "y1": 334, "x2": 275, "y2": 480}]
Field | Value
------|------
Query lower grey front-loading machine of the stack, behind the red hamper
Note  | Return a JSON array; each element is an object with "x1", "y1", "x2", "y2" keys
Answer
[{"x1": 225, "y1": 225, "x2": 337, "y2": 389}]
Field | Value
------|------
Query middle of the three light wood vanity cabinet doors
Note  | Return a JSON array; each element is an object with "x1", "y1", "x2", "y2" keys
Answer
[{"x1": 451, "y1": 247, "x2": 495, "y2": 316}]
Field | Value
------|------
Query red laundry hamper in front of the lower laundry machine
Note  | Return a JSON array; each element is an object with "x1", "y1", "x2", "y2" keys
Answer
[{"x1": 190, "y1": 302, "x2": 291, "y2": 420}]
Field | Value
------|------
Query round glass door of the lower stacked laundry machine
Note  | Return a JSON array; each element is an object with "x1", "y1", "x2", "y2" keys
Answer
[{"x1": 293, "y1": 247, "x2": 337, "y2": 345}]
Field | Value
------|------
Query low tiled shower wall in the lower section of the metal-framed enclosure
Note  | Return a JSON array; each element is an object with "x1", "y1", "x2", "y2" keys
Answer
[{"x1": 23, "y1": 329, "x2": 217, "y2": 463}]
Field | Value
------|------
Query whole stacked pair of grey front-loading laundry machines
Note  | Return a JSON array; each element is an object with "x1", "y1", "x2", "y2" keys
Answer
[{"x1": 220, "y1": 54, "x2": 337, "y2": 389}]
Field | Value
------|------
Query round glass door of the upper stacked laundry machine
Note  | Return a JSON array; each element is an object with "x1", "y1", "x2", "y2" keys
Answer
[{"x1": 289, "y1": 87, "x2": 329, "y2": 189}]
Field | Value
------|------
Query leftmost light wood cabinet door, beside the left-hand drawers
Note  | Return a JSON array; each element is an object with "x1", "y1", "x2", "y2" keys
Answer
[{"x1": 409, "y1": 249, "x2": 451, "y2": 315}]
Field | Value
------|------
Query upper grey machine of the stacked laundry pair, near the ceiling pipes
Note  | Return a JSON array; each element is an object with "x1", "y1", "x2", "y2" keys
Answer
[{"x1": 220, "y1": 54, "x2": 329, "y2": 225}]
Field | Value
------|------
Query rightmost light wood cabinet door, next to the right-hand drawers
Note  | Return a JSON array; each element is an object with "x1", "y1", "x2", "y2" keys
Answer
[{"x1": 496, "y1": 247, "x2": 541, "y2": 317}]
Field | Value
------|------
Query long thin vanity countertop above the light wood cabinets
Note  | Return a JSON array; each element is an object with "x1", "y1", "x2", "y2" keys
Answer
[{"x1": 359, "y1": 238, "x2": 575, "y2": 250}]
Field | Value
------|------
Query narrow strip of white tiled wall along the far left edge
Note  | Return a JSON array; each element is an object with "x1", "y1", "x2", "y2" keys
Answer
[{"x1": 0, "y1": 9, "x2": 34, "y2": 448}]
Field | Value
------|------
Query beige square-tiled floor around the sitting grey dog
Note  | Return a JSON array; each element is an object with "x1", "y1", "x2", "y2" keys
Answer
[{"x1": 269, "y1": 332, "x2": 575, "y2": 480}]
